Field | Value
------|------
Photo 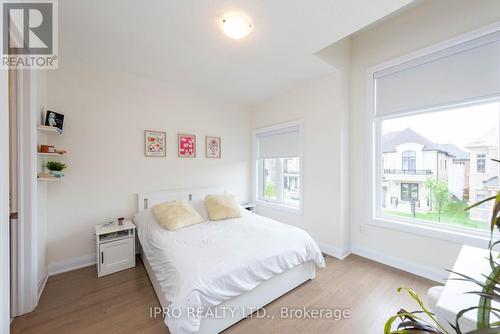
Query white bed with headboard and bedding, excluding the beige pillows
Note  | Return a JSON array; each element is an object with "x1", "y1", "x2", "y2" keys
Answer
[{"x1": 134, "y1": 188, "x2": 325, "y2": 334}]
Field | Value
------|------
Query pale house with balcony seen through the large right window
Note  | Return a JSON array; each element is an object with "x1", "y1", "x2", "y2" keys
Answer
[{"x1": 381, "y1": 128, "x2": 469, "y2": 213}]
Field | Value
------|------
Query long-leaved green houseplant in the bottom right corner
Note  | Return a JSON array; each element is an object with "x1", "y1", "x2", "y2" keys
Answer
[{"x1": 384, "y1": 159, "x2": 500, "y2": 334}]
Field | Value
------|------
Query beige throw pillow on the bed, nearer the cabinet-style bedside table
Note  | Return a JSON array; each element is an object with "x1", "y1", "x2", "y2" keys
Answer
[{"x1": 151, "y1": 201, "x2": 203, "y2": 231}]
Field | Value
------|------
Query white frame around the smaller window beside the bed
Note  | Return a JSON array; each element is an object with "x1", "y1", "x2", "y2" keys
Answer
[{"x1": 252, "y1": 120, "x2": 305, "y2": 215}]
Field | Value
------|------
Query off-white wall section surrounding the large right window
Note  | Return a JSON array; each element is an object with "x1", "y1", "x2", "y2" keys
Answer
[{"x1": 350, "y1": 0, "x2": 500, "y2": 277}]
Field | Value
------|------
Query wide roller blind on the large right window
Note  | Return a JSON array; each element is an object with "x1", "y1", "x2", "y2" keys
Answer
[{"x1": 374, "y1": 32, "x2": 500, "y2": 115}]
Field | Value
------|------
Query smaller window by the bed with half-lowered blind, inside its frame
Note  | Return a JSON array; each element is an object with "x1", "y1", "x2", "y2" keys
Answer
[{"x1": 255, "y1": 123, "x2": 302, "y2": 210}]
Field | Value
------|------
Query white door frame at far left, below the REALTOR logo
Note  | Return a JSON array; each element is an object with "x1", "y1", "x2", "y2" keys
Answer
[{"x1": 10, "y1": 70, "x2": 38, "y2": 317}]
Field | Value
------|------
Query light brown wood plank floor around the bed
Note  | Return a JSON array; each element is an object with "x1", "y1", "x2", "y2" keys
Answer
[{"x1": 11, "y1": 255, "x2": 436, "y2": 334}]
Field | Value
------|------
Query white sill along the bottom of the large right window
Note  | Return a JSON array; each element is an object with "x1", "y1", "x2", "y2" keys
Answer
[{"x1": 369, "y1": 217, "x2": 490, "y2": 248}]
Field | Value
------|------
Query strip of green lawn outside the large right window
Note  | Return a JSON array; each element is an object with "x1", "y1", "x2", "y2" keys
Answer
[{"x1": 384, "y1": 210, "x2": 489, "y2": 230}]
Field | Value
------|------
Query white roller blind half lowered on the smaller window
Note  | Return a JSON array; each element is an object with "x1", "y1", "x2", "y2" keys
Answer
[{"x1": 257, "y1": 126, "x2": 299, "y2": 159}]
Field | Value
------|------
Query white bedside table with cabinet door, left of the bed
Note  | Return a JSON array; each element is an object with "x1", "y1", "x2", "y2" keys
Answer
[{"x1": 95, "y1": 220, "x2": 135, "y2": 277}]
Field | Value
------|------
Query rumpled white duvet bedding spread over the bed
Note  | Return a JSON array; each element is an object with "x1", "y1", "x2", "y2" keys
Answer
[{"x1": 134, "y1": 209, "x2": 325, "y2": 334}]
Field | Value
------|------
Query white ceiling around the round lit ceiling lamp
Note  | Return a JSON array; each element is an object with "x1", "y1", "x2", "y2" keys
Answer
[{"x1": 59, "y1": 0, "x2": 412, "y2": 106}]
